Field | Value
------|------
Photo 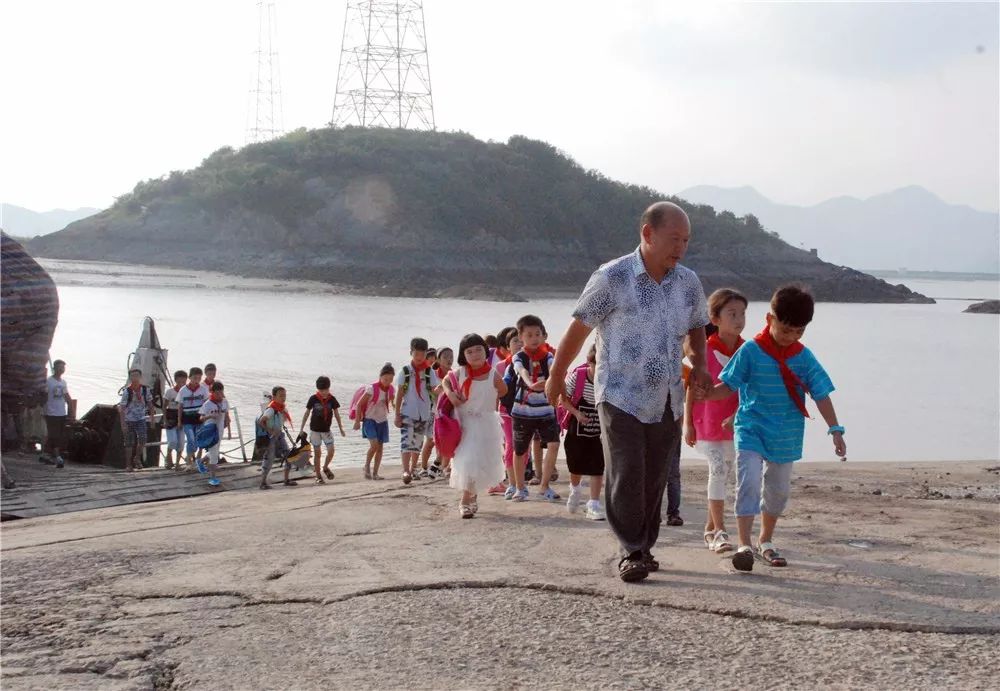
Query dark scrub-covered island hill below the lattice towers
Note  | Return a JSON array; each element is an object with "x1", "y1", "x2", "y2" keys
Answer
[{"x1": 28, "y1": 128, "x2": 930, "y2": 302}]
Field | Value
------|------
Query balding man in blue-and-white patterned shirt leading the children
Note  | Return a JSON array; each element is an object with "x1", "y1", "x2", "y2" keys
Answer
[{"x1": 546, "y1": 202, "x2": 712, "y2": 582}]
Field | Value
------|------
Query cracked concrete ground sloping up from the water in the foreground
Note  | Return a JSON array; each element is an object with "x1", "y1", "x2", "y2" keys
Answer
[{"x1": 0, "y1": 463, "x2": 1000, "y2": 689}]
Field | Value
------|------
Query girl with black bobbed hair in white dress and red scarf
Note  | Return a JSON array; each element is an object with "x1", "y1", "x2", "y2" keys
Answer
[{"x1": 443, "y1": 334, "x2": 507, "y2": 518}]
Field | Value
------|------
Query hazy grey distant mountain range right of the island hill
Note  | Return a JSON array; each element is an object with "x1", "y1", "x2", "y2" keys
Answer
[{"x1": 677, "y1": 185, "x2": 1000, "y2": 273}]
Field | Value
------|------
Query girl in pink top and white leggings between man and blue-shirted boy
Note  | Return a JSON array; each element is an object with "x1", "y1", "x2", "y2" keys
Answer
[{"x1": 684, "y1": 288, "x2": 747, "y2": 553}]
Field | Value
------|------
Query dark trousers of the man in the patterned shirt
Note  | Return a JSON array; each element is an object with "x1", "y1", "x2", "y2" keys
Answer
[{"x1": 597, "y1": 400, "x2": 681, "y2": 554}]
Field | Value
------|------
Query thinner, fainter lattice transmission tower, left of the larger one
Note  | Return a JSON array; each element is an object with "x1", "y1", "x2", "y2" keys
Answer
[{"x1": 247, "y1": 0, "x2": 283, "y2": 144}]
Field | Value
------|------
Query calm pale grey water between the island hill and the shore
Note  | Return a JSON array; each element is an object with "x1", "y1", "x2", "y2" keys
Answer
[{"x1": 43, "y1": 260, "x2": 1000, "y2": 464}]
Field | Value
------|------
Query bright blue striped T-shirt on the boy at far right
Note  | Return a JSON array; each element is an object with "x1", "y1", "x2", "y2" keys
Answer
[{"x1": 719, "y1": 341, "x2": 834, "y2": 463}]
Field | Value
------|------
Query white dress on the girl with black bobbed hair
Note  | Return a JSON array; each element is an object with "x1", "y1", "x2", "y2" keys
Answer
[{"x1": 450, "y1": 371, "x2": 504, "y2": 493}]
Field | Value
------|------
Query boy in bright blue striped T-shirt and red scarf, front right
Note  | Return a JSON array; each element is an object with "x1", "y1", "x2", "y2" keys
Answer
[{"x1": 695, "y1": 285, "x2": 847, "y2": 571}]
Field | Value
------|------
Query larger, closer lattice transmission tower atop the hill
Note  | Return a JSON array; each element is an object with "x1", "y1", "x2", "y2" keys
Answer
[{"x1": 330, "y1": 0, "x2": 435, "y2": 130}]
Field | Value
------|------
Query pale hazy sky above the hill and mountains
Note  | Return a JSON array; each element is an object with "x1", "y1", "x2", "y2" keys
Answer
[{"x1": 0, "y1": 0, "x2": 1000, "y2": 211}]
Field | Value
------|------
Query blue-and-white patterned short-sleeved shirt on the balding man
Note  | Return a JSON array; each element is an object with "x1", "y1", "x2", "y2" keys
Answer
[{"x1": 573, "y1": 248, "x2": 708, "y2": 424}]
